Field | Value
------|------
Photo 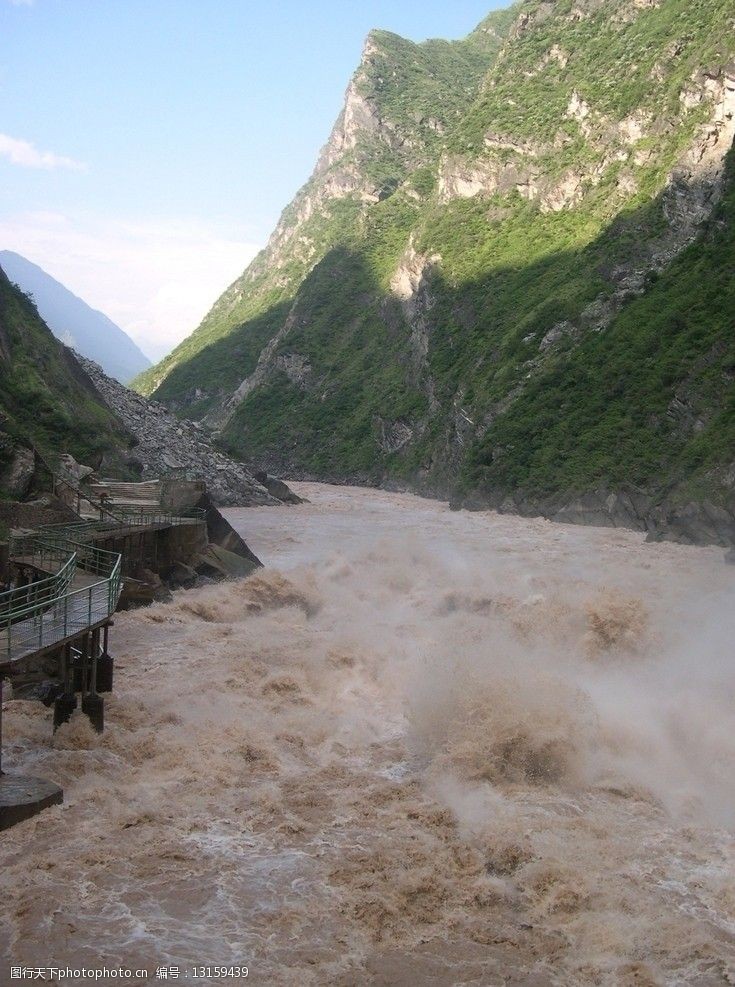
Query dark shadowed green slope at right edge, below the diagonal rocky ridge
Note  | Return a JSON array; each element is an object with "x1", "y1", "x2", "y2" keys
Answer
[{"x1": 464, "y1": 152, "x2": 735, "y2": 495}]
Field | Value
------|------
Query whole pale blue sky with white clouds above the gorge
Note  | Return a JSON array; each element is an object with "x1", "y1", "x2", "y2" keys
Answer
[{"x1": 0, "y1": 0, "x2": 507, "y2": 359}]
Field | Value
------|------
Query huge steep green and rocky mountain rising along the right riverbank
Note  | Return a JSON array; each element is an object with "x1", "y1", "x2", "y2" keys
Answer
[{"x1": 140, "y1": 0, "x2": 735, "y2": 542}]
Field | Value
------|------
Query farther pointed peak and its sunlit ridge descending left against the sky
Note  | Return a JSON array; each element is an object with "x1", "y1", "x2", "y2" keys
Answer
[{"x1": 133, "y1": 11, "x2": 512, "y2": 415}]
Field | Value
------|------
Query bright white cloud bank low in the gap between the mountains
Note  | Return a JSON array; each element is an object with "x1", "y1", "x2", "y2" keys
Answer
[{"x1": 0, "y1": 212, "x2": 259, "y2": 360}]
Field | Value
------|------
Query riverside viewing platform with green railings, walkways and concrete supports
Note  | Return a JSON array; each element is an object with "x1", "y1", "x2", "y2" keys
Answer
[{"x1": 0, "y1": 477, "x2": 213, "y2": 830}]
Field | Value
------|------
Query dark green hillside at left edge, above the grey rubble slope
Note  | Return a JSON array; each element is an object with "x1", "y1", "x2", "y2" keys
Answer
[{"x1": 0, "y1": 269, "x2": 130, "y2": 495}]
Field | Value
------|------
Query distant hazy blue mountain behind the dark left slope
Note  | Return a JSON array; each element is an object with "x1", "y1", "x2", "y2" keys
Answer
[{"x1": 0, "y1": 250, "x2": 151, "y2": 384}]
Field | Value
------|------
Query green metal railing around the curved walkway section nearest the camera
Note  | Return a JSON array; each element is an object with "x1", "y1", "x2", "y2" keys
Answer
[{"x1": 0, "y1": 535, "x2": 122, "y2": 662}]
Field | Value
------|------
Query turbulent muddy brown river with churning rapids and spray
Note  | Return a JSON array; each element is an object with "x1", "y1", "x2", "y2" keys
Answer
[{"x1": 0, "y1": 484, "x2": 735, "y2": 987}]
